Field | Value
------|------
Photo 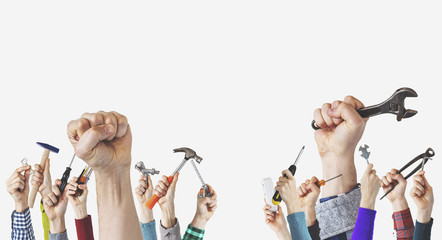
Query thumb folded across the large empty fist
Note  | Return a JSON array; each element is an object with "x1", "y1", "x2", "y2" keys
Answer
[{"x1": 75, "y1": 124, "x2": 115, "y2": 159}]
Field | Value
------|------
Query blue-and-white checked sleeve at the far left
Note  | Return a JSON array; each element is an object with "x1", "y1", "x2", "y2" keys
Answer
[{"x1": 11, "y1": 208, "x2": 35, "y2": 240}]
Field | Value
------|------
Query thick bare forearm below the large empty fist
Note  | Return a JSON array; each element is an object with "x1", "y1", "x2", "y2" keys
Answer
[{"x1": 95, "y1": 167, "x2": 142, "y2": 239}]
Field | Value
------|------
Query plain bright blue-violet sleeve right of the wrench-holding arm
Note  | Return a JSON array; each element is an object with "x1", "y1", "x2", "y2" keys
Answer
[{"x1": 352, "y1": 207, "x2": 376, "y2": 240}]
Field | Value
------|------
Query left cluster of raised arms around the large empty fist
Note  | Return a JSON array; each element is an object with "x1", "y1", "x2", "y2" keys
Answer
[{"x1": 6, "y1": 111, "x2": 217, "y2": 240}]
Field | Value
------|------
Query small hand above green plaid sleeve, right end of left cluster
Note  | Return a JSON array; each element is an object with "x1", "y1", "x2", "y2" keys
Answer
[{"x1": 191, "y1": 184, "x2": 217, "y2": 229}]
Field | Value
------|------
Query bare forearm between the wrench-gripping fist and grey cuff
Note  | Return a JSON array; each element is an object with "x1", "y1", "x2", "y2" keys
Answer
[{"x1": 321, "y1": 152, "x2": 357, "y2": 197}]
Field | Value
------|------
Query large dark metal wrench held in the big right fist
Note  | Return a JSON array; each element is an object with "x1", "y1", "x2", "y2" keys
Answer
[{"x1": 312, "y1": 87, "x2": 417, "y2": 130}]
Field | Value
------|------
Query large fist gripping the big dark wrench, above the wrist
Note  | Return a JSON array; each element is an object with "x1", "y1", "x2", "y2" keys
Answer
[{"x1": 314, "y1": 96, "x2": 368, "y2": 157}]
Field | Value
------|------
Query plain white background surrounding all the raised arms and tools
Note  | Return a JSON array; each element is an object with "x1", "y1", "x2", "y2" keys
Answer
[{"x1": 0, "y1": 1, "x2": 442, "y2": 239}]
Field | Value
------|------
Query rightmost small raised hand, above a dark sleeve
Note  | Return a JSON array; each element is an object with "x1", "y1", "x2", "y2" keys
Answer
[{"x1": 410, "y1": 170, "x2": 434, "y2": 223}]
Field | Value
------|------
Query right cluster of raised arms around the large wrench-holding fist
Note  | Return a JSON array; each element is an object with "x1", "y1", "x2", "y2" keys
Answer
[{"x1": 263, "y1": 96, "x2": 434, "y2": 240}]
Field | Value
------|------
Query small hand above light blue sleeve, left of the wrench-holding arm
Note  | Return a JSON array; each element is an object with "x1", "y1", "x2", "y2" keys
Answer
[{"x1": 275, "y1": 170, "x2": 301, "y2": 215}]
